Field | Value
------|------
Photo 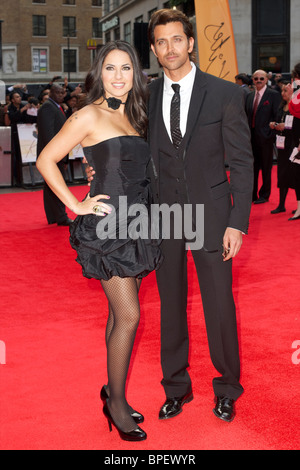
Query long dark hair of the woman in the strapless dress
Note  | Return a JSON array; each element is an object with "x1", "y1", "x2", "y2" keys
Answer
[{"x1": 84, "y1": 40, "x2": 148, "y2": 138}]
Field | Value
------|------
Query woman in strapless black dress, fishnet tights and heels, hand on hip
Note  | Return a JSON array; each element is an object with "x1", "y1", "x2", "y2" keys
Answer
[{"x1": 38, "y1": 41, "x2": 161, "y2": 441}]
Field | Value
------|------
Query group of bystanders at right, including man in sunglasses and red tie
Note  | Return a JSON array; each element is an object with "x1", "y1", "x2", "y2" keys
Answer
[{"x1": 235, "y1": 63, "x2": 300, "y2": 221}]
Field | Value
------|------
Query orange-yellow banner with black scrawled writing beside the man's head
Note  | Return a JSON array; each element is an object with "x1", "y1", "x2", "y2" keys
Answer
[{"x1": 195, "y1": 0, "x2": 238, "y2": 82}]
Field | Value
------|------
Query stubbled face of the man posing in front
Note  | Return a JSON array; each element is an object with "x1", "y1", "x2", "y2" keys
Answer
[{"x1": 151, "y1": 21, "x2": 194, "y2": 76}]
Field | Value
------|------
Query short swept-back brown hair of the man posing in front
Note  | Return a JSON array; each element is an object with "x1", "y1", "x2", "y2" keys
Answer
[{"x1": 148, "y1": 8, "x2": 197, "y2": 63}]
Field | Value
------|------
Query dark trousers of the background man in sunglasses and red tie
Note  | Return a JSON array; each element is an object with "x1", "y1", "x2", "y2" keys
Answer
[{"x1": 251, "y1": 129, "x2": 273, "y2": 200}]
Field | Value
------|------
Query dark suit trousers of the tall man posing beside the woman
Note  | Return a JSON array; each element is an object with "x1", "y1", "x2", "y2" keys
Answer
[{"x1": 157, "y1": 235, "x2": 243, "y2": 399}]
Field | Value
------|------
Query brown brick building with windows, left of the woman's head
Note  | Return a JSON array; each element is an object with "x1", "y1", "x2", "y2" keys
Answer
[{"x1": 0, "y1": 0, "x2": 102, "y2": 83}]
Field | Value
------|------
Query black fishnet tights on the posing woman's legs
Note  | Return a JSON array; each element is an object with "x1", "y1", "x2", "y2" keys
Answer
[{"x1": 101, "y1": 276, "x2": 141, "y2": 432}]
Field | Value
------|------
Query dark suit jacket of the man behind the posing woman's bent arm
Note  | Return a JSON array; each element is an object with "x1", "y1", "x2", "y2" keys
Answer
[{"x1": 37, "y1": 99, "x2": 67, "y2": 159}]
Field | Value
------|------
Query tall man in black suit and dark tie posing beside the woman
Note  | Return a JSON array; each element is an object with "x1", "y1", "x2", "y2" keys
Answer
[{"x1": 149, "y1": 10, "x2": 253, "y2": 421}]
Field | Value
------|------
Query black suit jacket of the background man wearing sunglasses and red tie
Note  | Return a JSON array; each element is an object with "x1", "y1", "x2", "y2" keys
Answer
[{"x1": 246, "y1": 87, "x2": 281, "y2": 141}]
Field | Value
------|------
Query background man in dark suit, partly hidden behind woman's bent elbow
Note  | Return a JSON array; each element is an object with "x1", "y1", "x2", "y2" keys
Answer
[{"x1": 37, "y1": 83, "x2": 73, "y2": 225}]
